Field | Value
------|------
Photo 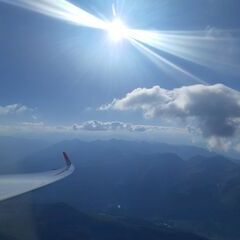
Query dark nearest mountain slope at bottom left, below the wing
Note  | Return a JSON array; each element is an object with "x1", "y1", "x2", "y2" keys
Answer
[{"x1": 0, "y1": 200, "x2": 207, "y2": 240}]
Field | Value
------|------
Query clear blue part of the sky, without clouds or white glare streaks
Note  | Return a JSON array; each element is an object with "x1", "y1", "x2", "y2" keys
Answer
[{"x1": 0, "y1": 0, "x2": 240, "y2": 150}]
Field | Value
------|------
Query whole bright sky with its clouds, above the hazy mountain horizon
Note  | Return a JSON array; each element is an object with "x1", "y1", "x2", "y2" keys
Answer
[{"x1": 0, "y1": 0, "x2": 240, "y2": 150}]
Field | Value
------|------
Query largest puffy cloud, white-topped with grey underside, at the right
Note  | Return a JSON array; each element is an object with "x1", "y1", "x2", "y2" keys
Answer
[{"x1": 100, "y1": 84, "x2": 240, "y2": 147}]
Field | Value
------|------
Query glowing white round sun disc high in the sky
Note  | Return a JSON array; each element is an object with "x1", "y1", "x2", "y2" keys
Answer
[{"x1": 107, "y1": 18, "x2": 128, "y2": 42}]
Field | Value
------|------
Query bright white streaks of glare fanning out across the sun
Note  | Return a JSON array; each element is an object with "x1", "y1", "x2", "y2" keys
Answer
[{"x1": 0, "y1": 0, "x2": 240, "y2": 82}]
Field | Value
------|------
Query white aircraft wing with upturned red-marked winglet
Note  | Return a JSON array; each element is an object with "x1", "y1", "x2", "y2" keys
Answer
[{"x1": 0, "y1": 152, "x2": 74, "y2": 201}]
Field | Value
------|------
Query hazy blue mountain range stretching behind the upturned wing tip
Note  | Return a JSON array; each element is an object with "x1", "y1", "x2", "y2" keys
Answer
[{"x1": 0, "y1": 137, "x2": 240, "y2": 240}]
